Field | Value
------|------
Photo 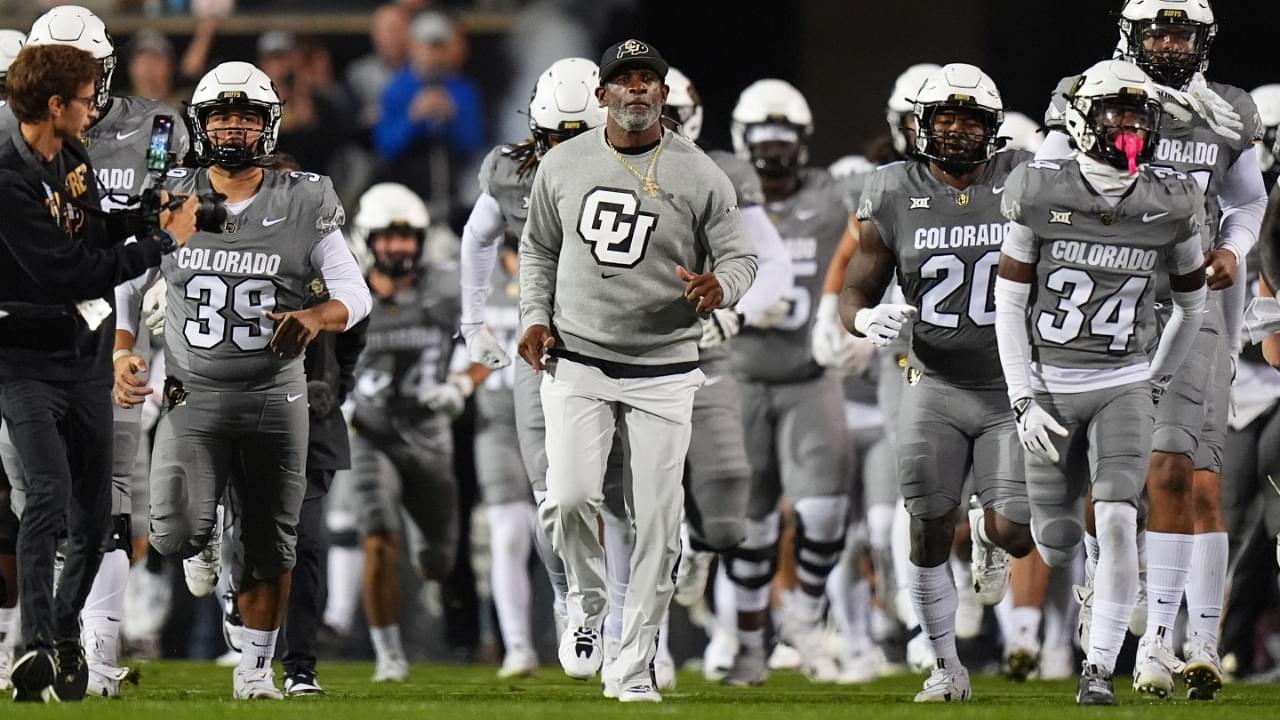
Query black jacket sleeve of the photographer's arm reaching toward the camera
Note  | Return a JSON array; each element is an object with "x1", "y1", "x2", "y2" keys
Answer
[{"x1": 0, "y1": 173, "x2": 160, "y2": 301}]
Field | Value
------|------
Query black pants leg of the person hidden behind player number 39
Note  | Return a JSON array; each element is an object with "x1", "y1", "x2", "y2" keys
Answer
[{"x1": 282, "y1": 470, "x2": 334, "y2": 675}]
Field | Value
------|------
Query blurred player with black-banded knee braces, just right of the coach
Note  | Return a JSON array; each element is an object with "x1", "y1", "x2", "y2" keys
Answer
[{"x1": 727, "y1": 79, "x2": 851, "y2": 684}]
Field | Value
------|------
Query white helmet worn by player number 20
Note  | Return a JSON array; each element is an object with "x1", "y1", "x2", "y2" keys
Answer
[{"x1": 911, "y1": 63, "x2": 1005, "y2": 174}]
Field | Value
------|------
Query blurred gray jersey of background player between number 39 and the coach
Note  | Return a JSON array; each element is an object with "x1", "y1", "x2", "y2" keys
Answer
[{"x1": 353, "y1": 263, "x2": 462, "y2": 425}]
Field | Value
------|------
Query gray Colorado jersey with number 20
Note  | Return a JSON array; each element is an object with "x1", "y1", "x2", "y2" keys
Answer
[{"x1": 858, "y1": 151, "x2": 1032, "y2": 388}]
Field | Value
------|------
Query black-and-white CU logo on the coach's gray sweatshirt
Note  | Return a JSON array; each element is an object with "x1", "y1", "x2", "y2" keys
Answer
[{"x1": 577, "y1": 187, "x2": 658, "y2": 268}]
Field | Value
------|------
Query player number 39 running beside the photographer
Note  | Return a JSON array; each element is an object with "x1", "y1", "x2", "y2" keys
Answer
[{"x1": 115, "y1": 63, "x2": 371, "y2": 700}]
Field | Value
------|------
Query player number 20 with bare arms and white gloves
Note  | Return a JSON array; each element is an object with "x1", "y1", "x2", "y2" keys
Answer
[{"x1": 840, "y1": 63, "x2": 1032, "y2": 702}]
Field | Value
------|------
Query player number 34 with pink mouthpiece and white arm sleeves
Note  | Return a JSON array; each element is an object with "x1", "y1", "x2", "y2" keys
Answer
[{"x1": 996, "y1": 60, "x2": 1206, "y2": 705}]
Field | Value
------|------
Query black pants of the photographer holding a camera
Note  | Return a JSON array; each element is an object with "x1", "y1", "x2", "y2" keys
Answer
[{"x1": 0, "y1": 378, "x2": 111, "y2": 648}]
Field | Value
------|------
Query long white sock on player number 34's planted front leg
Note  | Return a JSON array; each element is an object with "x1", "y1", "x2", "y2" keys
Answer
[{"x1": 1088, "y1": 501, "x2": 1138, "y2": 674}]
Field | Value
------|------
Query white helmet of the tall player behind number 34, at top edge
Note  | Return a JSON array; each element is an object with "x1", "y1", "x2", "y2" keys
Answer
[{"x1": 1120, "y1": 0, "x2": 1217, "y2": 88}]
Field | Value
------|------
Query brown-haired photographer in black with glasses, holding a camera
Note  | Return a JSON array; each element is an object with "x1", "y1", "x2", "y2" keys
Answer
[{"x1": 0, "y1": 45, "x2": 195, "y2": 701}]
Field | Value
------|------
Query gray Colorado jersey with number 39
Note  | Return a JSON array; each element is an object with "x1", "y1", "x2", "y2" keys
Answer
[{"x1": 160, "y1": 168, "x2": 344, "y2": 391}]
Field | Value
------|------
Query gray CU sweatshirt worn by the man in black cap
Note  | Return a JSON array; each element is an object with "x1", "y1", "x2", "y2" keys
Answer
[{"x1": 520, "y1": 127, "x2": 755, "y2": 365}]
